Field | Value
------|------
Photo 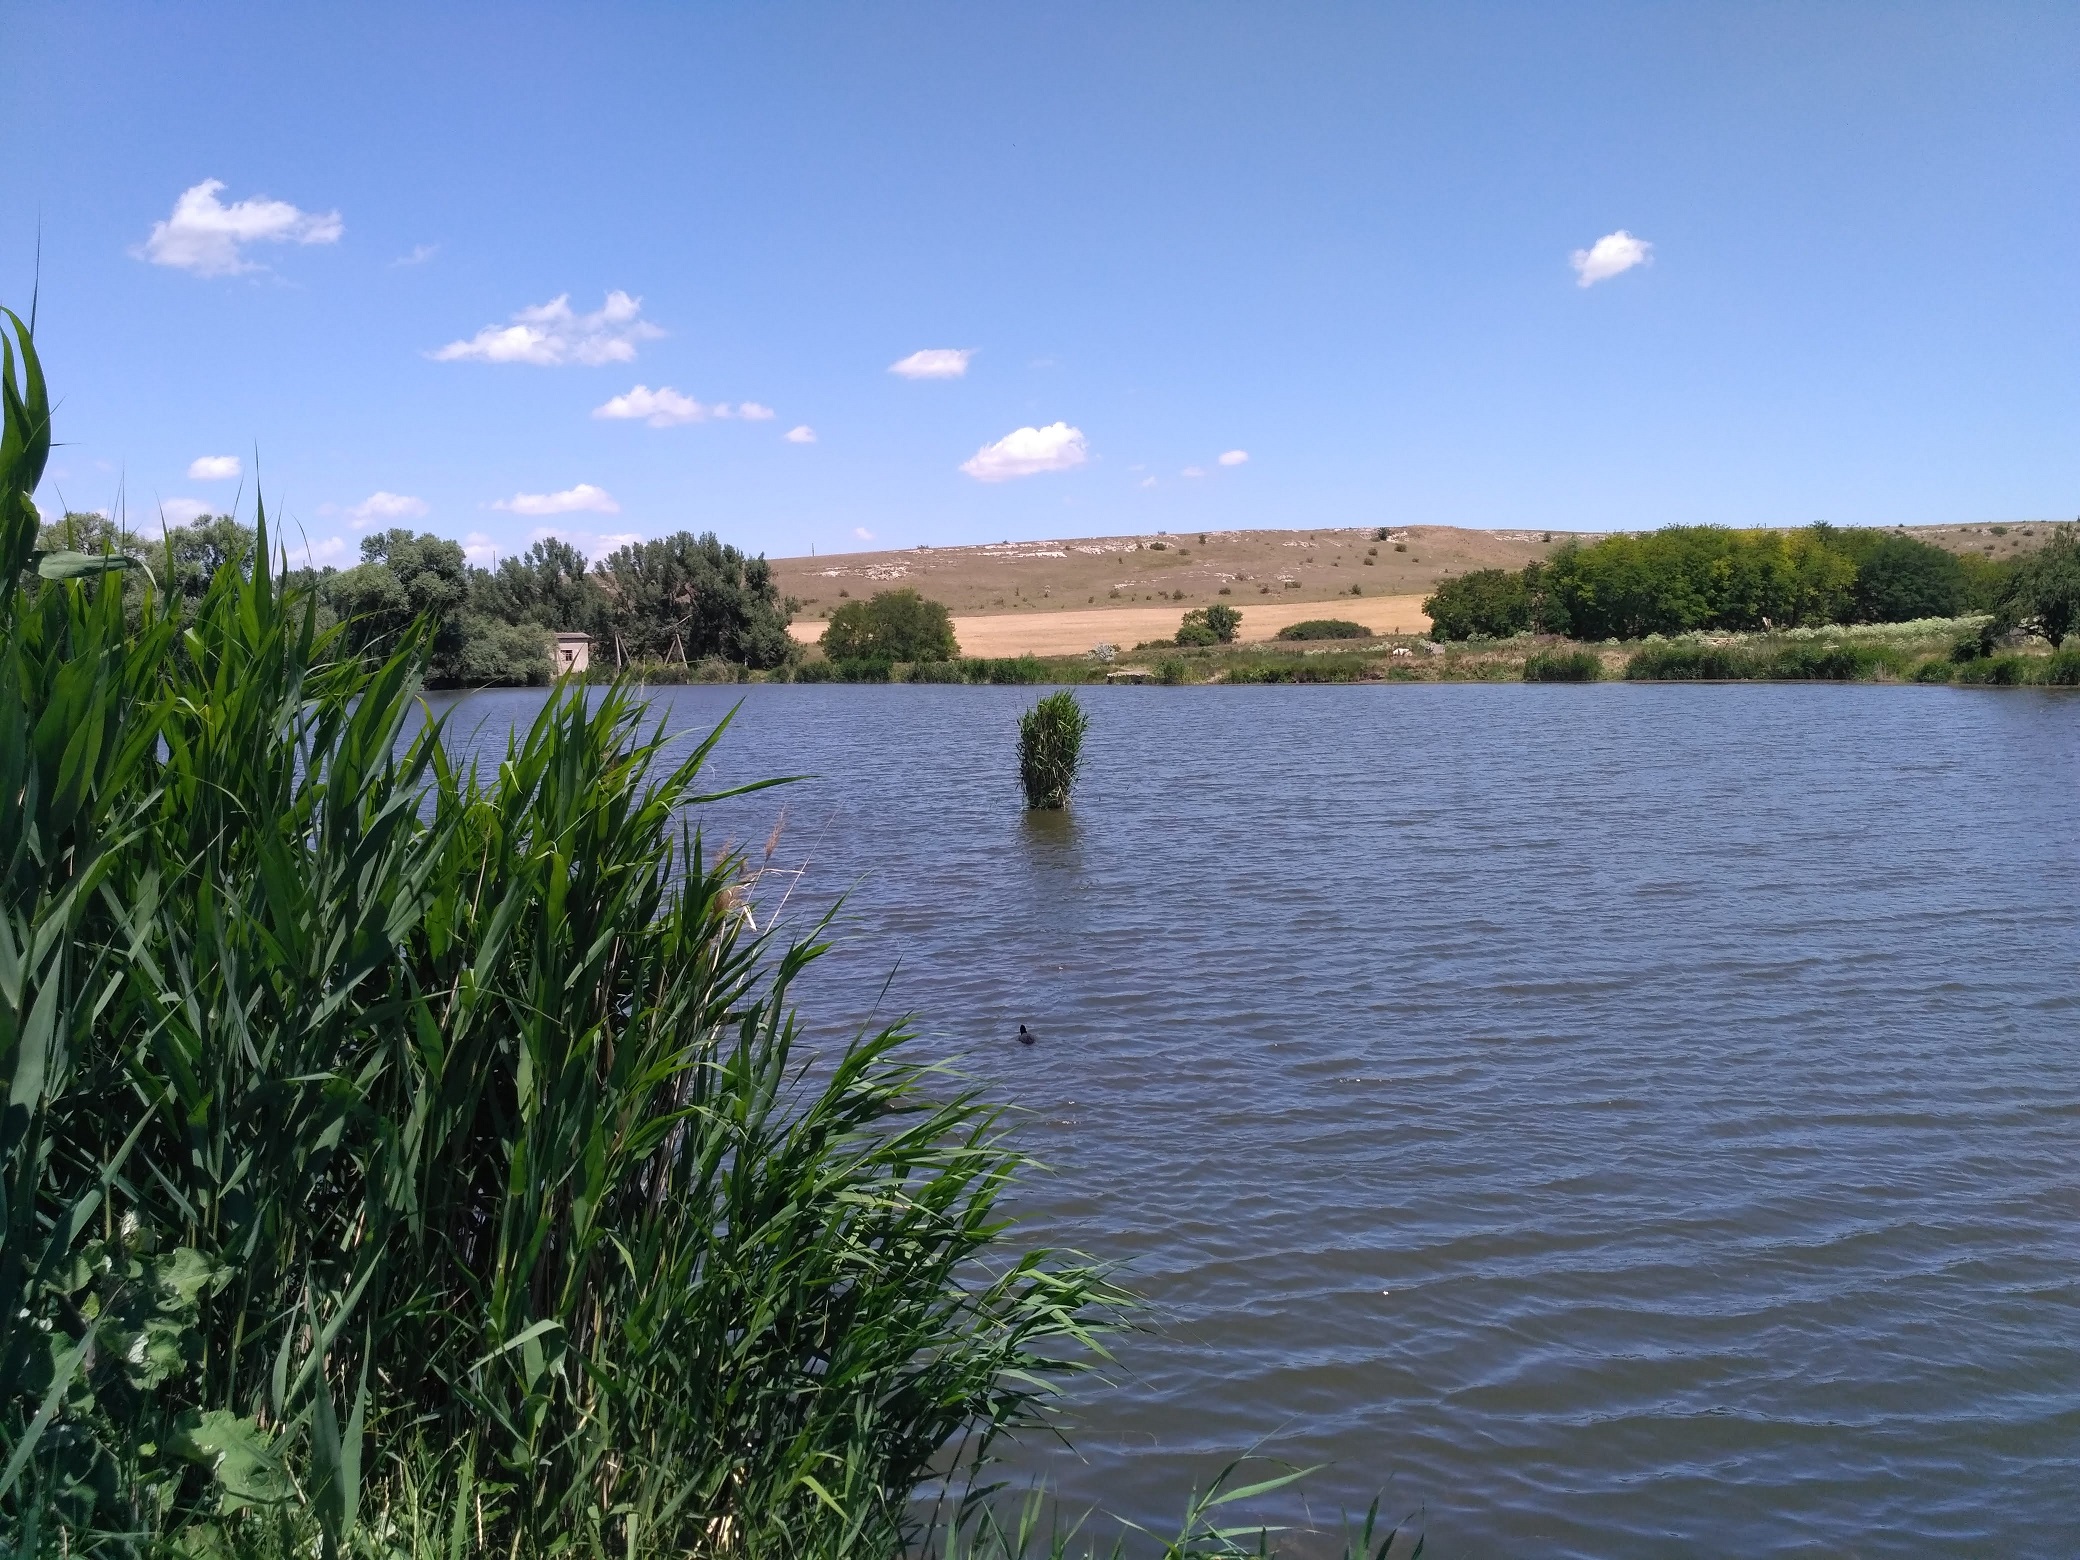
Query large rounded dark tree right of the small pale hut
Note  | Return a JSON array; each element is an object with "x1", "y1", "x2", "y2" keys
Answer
[{"x1": 593, "y1": 530, "x2": 795, "y2": 668}]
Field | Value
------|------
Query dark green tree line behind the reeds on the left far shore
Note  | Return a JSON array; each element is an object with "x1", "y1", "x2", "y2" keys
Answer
[{"x1": 40, "y1": 514, "x2": 797, "y2": 686}]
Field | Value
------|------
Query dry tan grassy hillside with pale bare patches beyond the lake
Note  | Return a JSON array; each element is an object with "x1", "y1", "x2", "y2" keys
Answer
[{"x1": 774, "y1": 522, "x2": 2045, "y2": 655}]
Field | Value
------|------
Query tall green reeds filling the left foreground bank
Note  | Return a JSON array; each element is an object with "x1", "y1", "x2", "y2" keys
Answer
[{"x1": 0, "y1": 312, "x2": 1431, "y2": 1560}]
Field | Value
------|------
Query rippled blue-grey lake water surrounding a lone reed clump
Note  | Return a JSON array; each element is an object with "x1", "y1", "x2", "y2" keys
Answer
[{"x1": 426, "y1": 686, "x2": 2080, "y2": 1556}]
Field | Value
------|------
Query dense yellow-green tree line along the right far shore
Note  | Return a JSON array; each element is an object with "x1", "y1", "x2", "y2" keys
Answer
[{"x1": 1423, "y1": 524, "x2": 2080, "y2": 645}]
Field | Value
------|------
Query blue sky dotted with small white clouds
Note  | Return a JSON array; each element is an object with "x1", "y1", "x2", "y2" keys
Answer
[{"x1": 0, "y1": 2, "x2": 2080, "y2": 562}]
